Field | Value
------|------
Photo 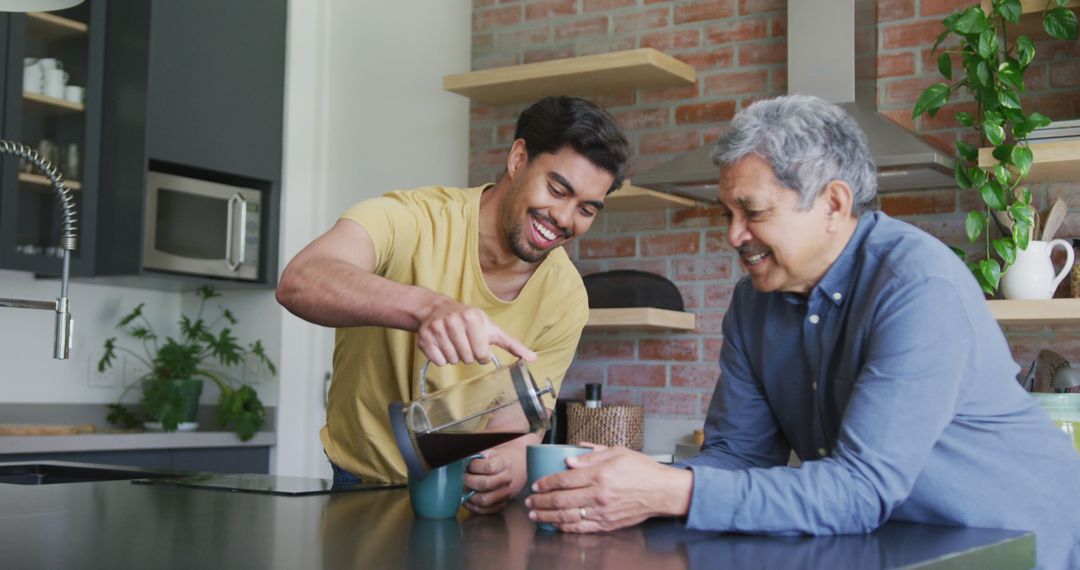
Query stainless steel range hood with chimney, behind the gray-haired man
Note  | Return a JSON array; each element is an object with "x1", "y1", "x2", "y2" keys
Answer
[{"x1": 633, "y1": 0, "x2": 955, "y2": 202}]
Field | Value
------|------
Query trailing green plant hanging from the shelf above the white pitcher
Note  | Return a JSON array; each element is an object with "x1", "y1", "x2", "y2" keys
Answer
[{"x1": 912, "y1": 0, "x2": 1077, "y2": 295}]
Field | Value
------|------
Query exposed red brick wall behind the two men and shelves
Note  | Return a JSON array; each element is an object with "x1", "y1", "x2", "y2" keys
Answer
[{"x1": 470, "y1": 0, "x2": 1080, "y2": 418}]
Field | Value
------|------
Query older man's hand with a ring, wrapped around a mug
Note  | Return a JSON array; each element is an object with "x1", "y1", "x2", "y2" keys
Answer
[{"x1": 525, "y1": 446, "x2": 693, "y2": 532}]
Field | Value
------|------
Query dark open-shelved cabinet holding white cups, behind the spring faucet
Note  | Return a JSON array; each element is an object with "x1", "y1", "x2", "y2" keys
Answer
[{"x1": 0, "y1": 0, "x2": 106, "y2": 275}]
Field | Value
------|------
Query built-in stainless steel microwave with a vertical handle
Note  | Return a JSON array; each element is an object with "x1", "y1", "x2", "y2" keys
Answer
[{"x1": 143, "y1": 171, "x2": 262, "y2": 281}]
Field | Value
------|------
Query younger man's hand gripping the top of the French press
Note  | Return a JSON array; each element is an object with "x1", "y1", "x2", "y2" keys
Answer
[{"x1": 416, "y1": 297, "x2": 537, "y2": 366}]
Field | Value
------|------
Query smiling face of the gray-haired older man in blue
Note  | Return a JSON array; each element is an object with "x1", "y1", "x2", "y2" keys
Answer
[{"x1": 719, "y1": 154, "x2": 858, "y2": 295}]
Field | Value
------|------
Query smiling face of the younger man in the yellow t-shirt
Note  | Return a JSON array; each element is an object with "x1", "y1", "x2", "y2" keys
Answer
[{"x1": 499, "y1": 140, "x2": 615, "y2": 263}]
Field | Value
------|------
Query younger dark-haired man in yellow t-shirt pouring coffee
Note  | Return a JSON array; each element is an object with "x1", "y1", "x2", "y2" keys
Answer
[{"x1": 278, "y1": 97, "x2": 627, "y2": 513}]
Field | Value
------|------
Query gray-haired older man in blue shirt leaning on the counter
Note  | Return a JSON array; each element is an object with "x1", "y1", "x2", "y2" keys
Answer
[{"x1": 528, "y1": 95, "x2": 1080, "y2": 568}]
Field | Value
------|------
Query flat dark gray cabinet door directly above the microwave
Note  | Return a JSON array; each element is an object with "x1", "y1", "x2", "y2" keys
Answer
[{"x1": 147, "y1": 0, "x2": 285, "y2": 180}]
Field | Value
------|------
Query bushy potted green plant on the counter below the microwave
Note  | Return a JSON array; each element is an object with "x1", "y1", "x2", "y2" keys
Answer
[{"x1": 97, "y1": 286, "x2": 276, "y2": 440}]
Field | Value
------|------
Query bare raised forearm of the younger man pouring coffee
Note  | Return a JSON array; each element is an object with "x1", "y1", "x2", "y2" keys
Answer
[{"x1": 278, "y1": 258, "x2": 447, "y2": 331}]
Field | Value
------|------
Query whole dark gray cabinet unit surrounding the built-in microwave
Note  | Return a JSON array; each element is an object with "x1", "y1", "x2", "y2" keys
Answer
[{"x1": 96, "y1": 0, "x2": 287, "y2": 288}]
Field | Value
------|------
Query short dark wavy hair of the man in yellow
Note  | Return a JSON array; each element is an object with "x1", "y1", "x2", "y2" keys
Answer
[{"x1": 514, "y1": 95, "x2": 630, "y2": 194}]
